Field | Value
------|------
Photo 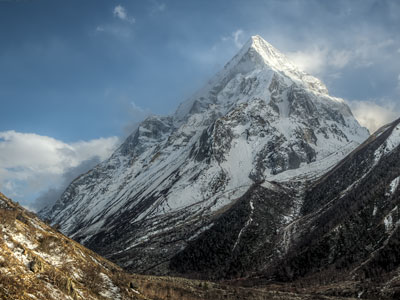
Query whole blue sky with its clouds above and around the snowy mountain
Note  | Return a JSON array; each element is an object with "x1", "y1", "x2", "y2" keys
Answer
[{"x1": 0, "y1": 0, "x2": 400, "y2": 207}]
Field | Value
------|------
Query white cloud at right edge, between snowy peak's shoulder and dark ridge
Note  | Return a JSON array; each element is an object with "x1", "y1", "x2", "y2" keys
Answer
[{"x1": 349, "y1": 101, "x2": 400, "y2": 133}]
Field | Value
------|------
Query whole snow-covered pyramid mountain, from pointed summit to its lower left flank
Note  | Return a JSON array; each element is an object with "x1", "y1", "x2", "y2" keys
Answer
[{"x1": 40, "y1": 36, "x2": 368, "y2": 272}]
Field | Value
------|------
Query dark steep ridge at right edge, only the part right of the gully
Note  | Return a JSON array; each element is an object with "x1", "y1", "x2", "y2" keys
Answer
[{"x1": 274, "y1": 119, "x2": 400, "y2": 286}]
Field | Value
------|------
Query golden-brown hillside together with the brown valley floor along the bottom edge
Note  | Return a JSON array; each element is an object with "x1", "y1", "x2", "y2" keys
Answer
[{"x1": 0, "y1": 194, "x2": 360, "y2": 300}]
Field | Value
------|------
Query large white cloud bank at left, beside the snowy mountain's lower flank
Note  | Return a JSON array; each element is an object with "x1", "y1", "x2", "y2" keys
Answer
[{"x1": 0, "y1": 131, "x2": 119, "y2": 207}]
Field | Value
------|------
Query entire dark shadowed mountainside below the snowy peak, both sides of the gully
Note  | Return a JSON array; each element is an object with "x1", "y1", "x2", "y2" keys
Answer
[{"x1": 170, "y1": 119, "x2": 400, "y2": 295}]
